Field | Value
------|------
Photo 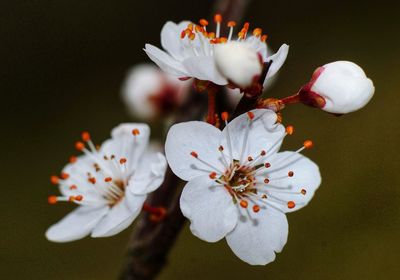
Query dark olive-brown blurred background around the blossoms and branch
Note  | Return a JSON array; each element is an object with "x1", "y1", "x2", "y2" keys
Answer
[{"x1": 0, "y1": 0, "x2": 400, "y2": 280}]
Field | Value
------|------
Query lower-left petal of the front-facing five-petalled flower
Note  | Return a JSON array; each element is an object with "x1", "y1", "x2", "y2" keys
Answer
[{"x1": 180, "y1": 176, "x2": 238, "y2": 242}]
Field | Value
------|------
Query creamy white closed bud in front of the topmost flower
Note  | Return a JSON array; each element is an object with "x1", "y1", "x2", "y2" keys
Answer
[{"x1": 214, "y1": 42, "x2": 262, "y2": 88}]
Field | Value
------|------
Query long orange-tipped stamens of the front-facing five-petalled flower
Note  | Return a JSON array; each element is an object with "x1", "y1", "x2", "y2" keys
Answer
[{"x1": 191, "y1": 112, "x2": 313, "y2": 213}]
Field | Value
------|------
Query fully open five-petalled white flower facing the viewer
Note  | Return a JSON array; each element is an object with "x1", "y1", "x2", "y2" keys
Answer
[{"x1": 165, "y1": 109, "x2": 321, "y2": 265}]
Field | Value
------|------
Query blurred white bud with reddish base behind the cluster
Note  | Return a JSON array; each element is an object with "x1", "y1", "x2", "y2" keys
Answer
[{"x1": 122, "y1": 64, "x2": 189, "y2": 120}]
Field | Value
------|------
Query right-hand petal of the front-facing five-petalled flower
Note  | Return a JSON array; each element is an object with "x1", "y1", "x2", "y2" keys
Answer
[{"x1": 261, "y1": 152, "x2": 321, "y2": 212}]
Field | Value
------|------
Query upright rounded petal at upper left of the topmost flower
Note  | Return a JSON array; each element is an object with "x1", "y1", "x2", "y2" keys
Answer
[{"x1": 161, "y1": 21, "x2": 189, "y2": 60}]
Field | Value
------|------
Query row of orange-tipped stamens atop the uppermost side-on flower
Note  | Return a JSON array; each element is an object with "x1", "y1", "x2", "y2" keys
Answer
[{"x1": 181, "y1": 14, "x2": 268, "y2": 44}]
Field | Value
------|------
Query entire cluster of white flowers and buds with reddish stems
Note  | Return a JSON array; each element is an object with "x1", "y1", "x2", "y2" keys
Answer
[{"x1": 46, "y1": 14, "x2": 375, "y2": 265}]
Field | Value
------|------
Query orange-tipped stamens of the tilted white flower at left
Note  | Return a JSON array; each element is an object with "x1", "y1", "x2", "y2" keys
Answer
[{"x1": 48, "y1": 129, "x2": 140, "y2": 207}]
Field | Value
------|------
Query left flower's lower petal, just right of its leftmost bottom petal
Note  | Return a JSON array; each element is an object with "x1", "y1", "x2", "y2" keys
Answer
[{"x1": 91, "y1": 191, "x2": 146, "y2": 237}]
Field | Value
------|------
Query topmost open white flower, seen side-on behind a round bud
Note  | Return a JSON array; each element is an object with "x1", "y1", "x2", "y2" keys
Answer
[{"x1": 144, "y1": 14, "x2": 289, "y2": 85}]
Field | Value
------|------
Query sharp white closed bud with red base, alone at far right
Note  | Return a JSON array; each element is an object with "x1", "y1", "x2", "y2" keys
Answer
[{"x1": 300, "y1": 61, "x2": 375, "y2": 114}]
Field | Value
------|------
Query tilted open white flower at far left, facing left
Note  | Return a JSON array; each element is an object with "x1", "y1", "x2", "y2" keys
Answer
[{"x1": 46, "y1": 123, "x2": 167, "y2": 242}]
